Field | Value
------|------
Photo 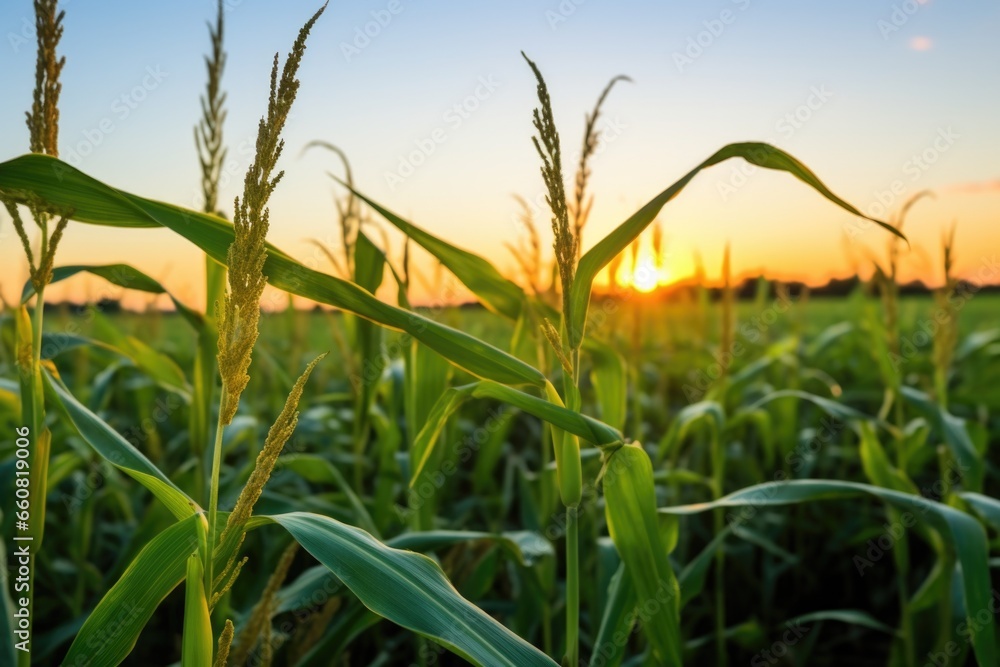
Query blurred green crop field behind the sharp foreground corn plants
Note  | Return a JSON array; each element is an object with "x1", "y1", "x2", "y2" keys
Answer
[{"x1": 2, "y1": 293, "x2": 1000, "y2": 665}]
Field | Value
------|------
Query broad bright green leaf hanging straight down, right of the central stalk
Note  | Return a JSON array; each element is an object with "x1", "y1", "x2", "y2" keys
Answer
[{"x1": 604, "y1": 444, "x2": 683, "y2": 667}]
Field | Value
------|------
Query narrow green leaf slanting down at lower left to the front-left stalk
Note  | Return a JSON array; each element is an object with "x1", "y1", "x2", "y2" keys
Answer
[{"x1": 44, "y1": 372, "x2": 201, "y2": 519}]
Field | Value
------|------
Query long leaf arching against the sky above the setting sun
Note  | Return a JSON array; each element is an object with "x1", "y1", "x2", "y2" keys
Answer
[{"x1": 567, "y1": 142, "x2": 906, "y2": 348}]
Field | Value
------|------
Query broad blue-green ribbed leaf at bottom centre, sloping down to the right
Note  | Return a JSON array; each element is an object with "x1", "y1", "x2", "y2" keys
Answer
[{"x1": 271, "y1": 512, "x2": 555, "y2": 667}]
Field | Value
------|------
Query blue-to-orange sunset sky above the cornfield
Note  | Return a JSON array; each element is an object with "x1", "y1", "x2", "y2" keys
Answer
[{"x1": 0, "y1": 0, "x2": 1000, "y2": 307}]
